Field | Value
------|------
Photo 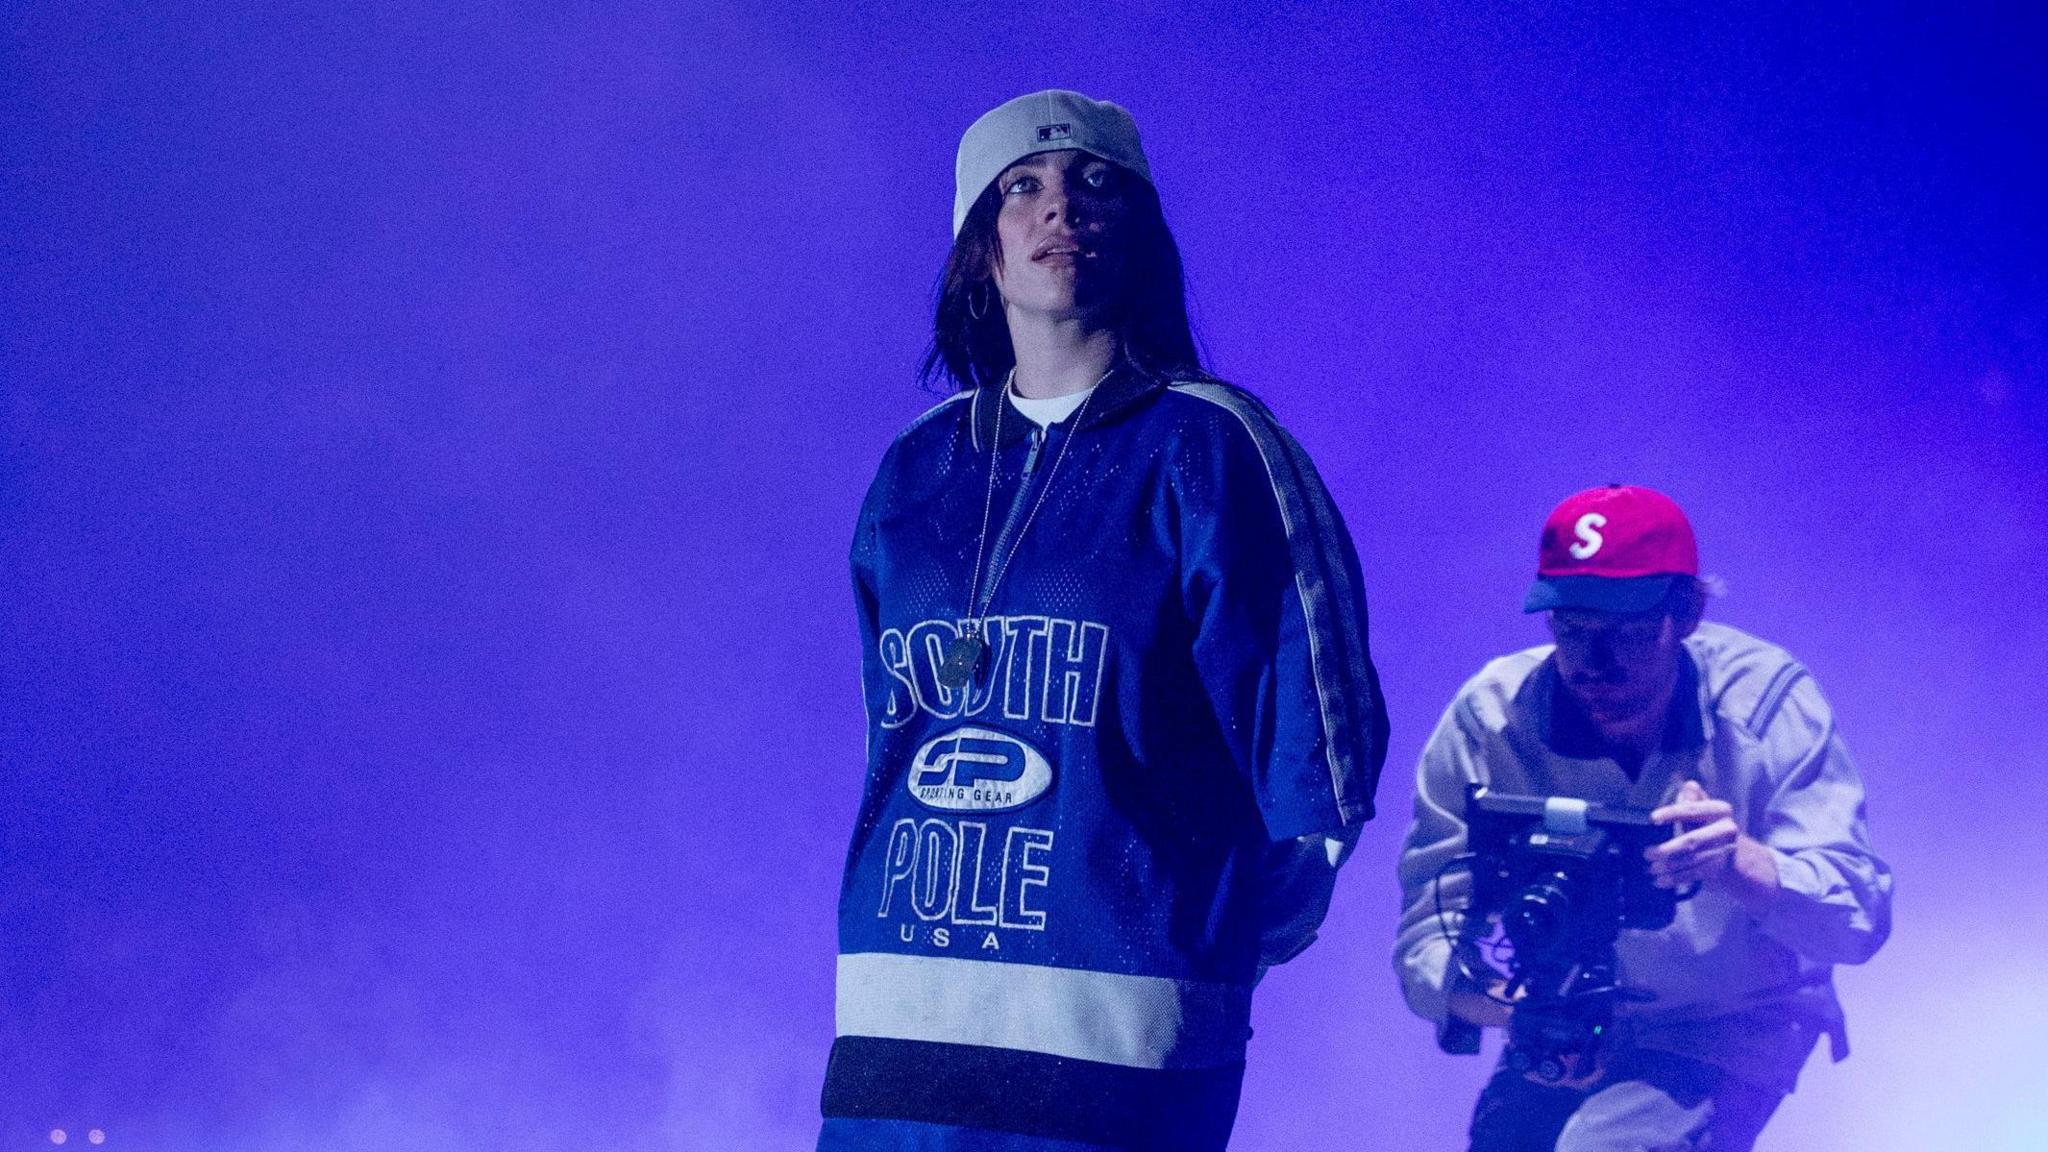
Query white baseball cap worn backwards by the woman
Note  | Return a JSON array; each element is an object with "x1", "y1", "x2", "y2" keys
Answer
[{"x1": 952, "y1": 88, "x2": 1151, "y2": 236}]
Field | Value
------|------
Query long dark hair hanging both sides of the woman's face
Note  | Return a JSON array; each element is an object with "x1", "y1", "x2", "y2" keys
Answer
[{"x1": 918, "y1": 166, "x2": 1208, "y2": 392}]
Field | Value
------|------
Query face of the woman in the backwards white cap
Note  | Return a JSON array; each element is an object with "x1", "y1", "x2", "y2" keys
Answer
[{"x1": 993, "y1": 150, "x2": 1130, "y2": 320}]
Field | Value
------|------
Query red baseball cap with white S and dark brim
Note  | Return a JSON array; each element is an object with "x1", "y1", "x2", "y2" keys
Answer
[{"x1": 1522, "y1": 484, "x2": 1700, "y2": 613}]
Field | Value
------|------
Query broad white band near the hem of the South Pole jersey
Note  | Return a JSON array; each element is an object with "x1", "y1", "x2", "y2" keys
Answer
[{"x1": 836, "y1": 951, "x2": 1251, "y2": 1068}]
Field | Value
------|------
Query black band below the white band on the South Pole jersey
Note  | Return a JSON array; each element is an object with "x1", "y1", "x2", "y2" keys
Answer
[{"x1": 823, "y1": 1035, "x2": 1245, "y2": 1152}]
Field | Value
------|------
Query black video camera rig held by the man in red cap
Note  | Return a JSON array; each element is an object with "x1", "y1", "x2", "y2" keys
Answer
[{"x1": 1454, "y1": 783, "x2": 1690, "y2": 1084}]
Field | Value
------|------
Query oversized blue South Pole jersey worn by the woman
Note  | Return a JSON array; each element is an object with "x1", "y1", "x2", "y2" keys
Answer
[{"x1": 821, "y1": 367, "x2": 1386, "y2": 1152}]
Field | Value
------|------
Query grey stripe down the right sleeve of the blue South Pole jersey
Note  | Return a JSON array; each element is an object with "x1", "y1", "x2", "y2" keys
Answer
[{"x1": 1174, "y1": 383, "x2": 1382, "y2": 820}]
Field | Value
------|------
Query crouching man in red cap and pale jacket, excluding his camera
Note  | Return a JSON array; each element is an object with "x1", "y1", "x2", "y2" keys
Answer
[{"x1": 1395, "y1": 486, "x2": 1892, "y2": 1152}]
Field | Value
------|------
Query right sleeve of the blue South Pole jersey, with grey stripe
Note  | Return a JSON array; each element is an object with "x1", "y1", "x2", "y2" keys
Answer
[{"x1": 1176, "y1": 383, "x2": 1386, "y2": 840}]
